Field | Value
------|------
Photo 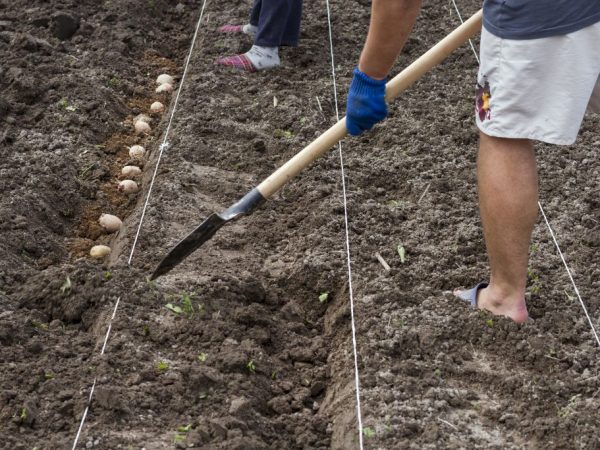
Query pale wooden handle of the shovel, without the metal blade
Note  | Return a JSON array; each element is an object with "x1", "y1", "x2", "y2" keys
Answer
[{"x1": 257, "y1": 10, "x2": 482, "y2": 199}]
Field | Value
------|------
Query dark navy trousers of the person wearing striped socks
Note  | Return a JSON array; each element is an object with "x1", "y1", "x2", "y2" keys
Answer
[{"x1": 250, "y1": 0, "x2": 302, "y2": 47}]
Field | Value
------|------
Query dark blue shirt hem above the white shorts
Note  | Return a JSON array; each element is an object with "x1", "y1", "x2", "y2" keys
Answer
[{"x1": 483, "y1": 0, "x2": 600, "y2": 39}]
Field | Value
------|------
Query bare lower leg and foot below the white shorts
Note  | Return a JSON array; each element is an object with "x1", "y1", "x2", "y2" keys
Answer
[{"x1": 477, "y1": 133, "x2": 538, "y2": 322}]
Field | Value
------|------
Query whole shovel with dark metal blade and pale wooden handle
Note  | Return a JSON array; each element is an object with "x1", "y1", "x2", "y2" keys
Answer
[{"x1": 150, "y1": 10, "x2": 482, "y2": 280}]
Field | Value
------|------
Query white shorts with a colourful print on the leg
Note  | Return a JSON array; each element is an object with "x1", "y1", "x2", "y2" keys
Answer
[{"x1": 475, "y1": 22, "x2": 600, "y2": 145}]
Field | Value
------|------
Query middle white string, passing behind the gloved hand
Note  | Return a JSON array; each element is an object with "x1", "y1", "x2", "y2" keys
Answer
[{"x1": 326, "y1": 0, "x2": 363, "y2": 450}]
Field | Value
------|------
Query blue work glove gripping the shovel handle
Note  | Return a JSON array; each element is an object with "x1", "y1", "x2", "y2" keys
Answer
[{"x1": 346, "y1": 67, "x2": 387, "y2": 136}]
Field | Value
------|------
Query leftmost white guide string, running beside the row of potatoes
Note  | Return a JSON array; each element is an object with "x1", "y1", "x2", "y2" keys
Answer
[{"x1": 72, "y1": 0, "x2": 207, "y2": 450}]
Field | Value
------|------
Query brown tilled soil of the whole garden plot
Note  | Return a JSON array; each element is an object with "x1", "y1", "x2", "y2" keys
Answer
[{"x1": 0, "y1": 0, "x2": 600, "y2": 450}]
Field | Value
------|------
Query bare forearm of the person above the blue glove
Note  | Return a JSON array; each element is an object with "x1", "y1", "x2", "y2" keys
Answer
[{"x1": 358, "y1": 0, "x2": 421, "y2": 80}]
